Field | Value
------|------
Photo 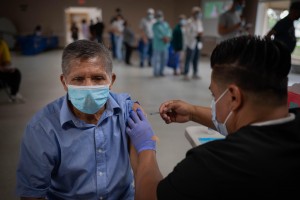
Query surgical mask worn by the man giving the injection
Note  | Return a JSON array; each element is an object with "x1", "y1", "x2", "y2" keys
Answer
[{"x1": 211, "y1": 89, "x2": 232, "y2": 136}]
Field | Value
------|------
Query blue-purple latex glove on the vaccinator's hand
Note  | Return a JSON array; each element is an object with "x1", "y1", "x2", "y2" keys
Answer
[{"x1": 126, "y1": 108, "x2": 156, "y2": 153}]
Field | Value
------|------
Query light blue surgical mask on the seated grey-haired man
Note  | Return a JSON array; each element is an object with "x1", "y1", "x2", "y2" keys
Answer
[{"x1": 68, "y1": 85, "x2": 109, "y2": 114}]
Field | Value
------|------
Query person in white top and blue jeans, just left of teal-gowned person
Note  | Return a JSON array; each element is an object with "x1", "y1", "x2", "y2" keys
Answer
[{"x1": 140, "y1": 8, "x2": 156, "y2": 67}]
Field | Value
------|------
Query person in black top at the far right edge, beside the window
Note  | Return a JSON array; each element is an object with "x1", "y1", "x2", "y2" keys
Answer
[{"x1": 266, "y1": 1, "x2": 300, "y2": 53}]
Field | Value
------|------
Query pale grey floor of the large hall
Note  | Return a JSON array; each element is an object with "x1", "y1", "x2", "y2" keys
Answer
[{"x1": 0, "y1": 50, "x2": 300, "y2": 200}]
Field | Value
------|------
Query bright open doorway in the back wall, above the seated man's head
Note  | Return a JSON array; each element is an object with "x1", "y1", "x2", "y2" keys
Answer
[{"x1": 65, "y1": 7, "x2": 102, "y2": 45}]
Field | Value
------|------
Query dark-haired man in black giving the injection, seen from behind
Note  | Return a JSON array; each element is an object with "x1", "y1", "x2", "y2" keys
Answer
[{"x1": 126, "y1": 36, "x2": 300, "y2": 200}]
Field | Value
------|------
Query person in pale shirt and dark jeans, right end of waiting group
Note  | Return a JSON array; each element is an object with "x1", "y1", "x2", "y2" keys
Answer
[{"x1": 184, "y1": 6, "x2": 203, "y2": 80}]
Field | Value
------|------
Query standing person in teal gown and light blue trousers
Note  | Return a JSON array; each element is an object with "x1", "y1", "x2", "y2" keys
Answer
[{"x1": 152, "y1": 10, "x2": 172, "y2": 77}]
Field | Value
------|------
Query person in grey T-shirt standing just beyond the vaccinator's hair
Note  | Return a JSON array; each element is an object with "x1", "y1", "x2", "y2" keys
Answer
[{"x1": 218, "y1": 0, "x2": 245, "y2": 41}]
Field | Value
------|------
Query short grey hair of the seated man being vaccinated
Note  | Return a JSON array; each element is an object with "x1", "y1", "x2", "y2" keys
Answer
[{"x1": 61, "y1": 40, "x2": 112, "y2": 76}]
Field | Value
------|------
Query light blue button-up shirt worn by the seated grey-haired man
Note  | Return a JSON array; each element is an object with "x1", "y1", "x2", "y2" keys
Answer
[{"x1": 17, "y1": 93, "x2": 134, "y2": 200}]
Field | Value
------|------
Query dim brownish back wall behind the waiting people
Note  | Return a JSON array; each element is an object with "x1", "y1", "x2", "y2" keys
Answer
[{"x1": 0, "y1": 0, "x2": 201, "y2": 47}]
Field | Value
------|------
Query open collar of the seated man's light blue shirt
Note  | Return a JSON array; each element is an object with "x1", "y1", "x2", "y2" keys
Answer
[{"x1": 60, "y1": 93, "x2": 121, "y2": 127}]
